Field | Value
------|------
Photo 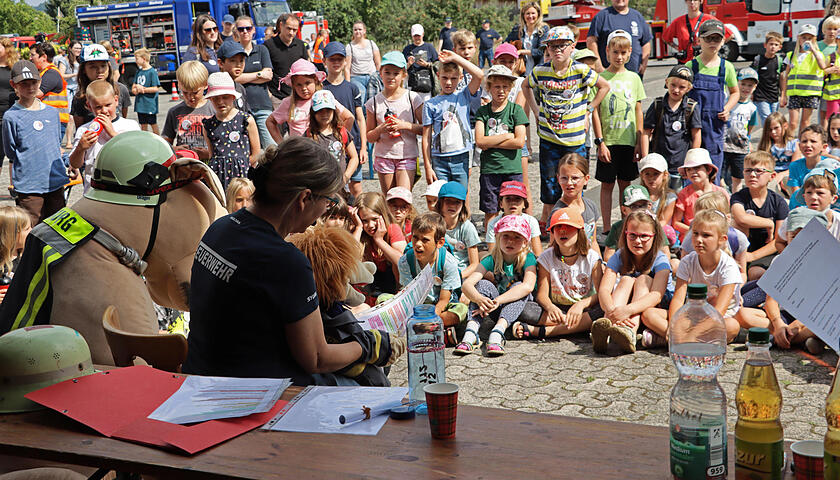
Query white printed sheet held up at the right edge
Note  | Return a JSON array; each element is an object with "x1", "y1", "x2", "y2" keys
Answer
[{"x1": 758, "y1": 219, "x2": 840, "y2": 351}]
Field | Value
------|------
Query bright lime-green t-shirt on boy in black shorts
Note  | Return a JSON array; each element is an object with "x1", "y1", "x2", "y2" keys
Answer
[{"x1": 599, "y1": 70, "x2": 645, "y2": 145}]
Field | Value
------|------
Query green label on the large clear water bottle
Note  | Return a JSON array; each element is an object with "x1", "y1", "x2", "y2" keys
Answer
[{"x1": 671, "y1": 424, "x2": 726, "y2": 480}]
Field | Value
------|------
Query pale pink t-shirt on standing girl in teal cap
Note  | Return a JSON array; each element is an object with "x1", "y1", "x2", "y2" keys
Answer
[{"x1": 365, "y1": 91, "x2": 423, "y2": 160}]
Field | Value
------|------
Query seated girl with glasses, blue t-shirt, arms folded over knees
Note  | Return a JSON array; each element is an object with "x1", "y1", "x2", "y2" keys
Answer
[{"x1": 591, "y1": 210, "x2": 674, "y2": 354}]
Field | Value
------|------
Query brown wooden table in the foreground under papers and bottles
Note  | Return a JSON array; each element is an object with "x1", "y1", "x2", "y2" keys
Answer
[{"x1": 0, "y1": 387, "x2": 793, "y2": 480}]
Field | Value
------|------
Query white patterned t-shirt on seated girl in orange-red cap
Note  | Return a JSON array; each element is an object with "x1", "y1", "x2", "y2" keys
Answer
[{"x1": 537, "y1": 247, "x2": 601, "y2": 305}]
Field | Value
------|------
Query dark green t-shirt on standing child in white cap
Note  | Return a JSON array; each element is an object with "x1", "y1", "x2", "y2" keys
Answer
[{"x1": 475, "y1": 102, "x2": 528, "y2": 174}]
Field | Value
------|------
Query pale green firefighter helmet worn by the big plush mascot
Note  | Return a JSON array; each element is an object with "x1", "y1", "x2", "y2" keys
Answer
[{"x1": 85, "y1": 131, "x2": 175, "y2": 205}]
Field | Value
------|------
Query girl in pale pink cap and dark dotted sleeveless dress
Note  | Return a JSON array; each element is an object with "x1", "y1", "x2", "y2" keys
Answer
[{"x1": 202, "y1": 72, "x2": 260, "y2": 188}]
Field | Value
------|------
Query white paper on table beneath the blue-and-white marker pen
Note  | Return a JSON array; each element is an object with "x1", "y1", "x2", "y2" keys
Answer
[{"x1": 263, "y1": 386, "x2": 408, "y2": 435}]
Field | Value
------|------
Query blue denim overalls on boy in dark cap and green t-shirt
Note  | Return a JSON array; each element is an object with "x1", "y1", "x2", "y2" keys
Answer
[{"x1": 688, "y1": 58, "x2": 726, "y2": 185}]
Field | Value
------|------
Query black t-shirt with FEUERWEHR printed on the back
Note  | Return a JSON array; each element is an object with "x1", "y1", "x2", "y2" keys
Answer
[{"x1": 183, "y1": 209, "x2": 318, "y2": 385}]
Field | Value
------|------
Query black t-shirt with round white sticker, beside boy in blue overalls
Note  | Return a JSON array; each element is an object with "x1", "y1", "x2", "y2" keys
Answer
[{"x1": 643, "y1": 95, "x2": 703, "y2": 175}]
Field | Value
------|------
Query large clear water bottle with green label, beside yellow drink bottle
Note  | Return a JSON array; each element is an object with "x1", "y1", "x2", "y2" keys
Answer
[{"x1": 668, "y1": 284, "x2": 727, "y2": 480}]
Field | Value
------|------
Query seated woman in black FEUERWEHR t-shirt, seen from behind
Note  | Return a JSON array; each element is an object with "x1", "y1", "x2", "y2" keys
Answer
[{"x1": 183, "y1": 137, "x2": 399, "y2": 385}]
